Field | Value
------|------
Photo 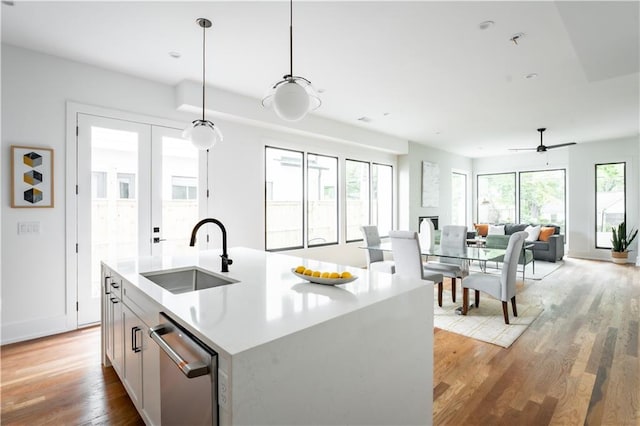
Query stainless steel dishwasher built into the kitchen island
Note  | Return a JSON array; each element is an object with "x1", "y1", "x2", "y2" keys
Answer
[{"x1": 149, "y1": 313, "x2": 218, "y2": 426}]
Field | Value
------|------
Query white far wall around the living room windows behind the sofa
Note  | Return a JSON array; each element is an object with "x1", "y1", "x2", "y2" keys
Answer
[{"x1": 473, "y1": 137, "x2": 640, "y2": 261}]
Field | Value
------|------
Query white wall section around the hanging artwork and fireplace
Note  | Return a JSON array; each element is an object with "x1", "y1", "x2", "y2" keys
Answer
[{"x1": 398, "y1": 142, "x2": 473, "y2": 231}]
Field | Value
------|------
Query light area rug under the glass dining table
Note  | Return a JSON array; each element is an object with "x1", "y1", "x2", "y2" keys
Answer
[{"x1": 433, "y1": 292, "x2": 543, "y2": 348}]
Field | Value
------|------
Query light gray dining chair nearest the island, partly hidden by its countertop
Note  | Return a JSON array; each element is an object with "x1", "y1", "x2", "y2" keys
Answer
[{"x1": 389, "y1": 231, "x2": 443, "y2": 306}]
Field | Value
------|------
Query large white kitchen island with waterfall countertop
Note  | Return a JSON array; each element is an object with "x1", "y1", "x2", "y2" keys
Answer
[{"x1": 103, "y1": 247, "x2": 433, "y2": 425}]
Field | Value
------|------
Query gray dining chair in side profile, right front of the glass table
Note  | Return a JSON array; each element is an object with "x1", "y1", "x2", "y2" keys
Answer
[{"x1": 462, "y1": 231, "x2": 528, "y2": 324}]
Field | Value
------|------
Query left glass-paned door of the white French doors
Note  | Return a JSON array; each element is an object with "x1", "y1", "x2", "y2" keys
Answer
[{"x1": 77, "y1": 114, "x2": 151, "y2": 325}]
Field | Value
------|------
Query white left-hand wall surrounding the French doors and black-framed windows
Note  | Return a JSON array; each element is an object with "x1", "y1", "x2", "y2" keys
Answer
[{"x1": 1, "y1": 45, "x2": 406, "y2": 343}]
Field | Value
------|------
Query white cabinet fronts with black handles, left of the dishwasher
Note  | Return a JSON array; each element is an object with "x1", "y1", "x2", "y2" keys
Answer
[{"x1": 102, "y1": 265, "x2": 160, "y2": 425}]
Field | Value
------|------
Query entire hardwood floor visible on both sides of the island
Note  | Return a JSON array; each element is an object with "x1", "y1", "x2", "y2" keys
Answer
[{"x1": 0, "y1": 259, "x2": 640, "y2": 426}]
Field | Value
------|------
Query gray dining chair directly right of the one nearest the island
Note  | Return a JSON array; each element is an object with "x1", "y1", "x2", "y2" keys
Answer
[{"x1": 425, "y1": 225, "x2": 469, "y2": 302}]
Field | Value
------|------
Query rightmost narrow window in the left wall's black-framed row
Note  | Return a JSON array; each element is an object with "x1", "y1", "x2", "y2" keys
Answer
[{"x1": 372, "y1": 164, "x2": 393, "y2": 236}]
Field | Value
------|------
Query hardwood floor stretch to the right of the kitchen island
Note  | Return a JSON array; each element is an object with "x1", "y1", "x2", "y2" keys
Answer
[{"x1": 434, "y1": 259, "x2": 640, "y2": 426}]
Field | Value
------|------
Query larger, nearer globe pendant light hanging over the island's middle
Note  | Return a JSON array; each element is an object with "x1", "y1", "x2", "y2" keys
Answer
[{"x1": 262, "y1": 0, "x2": 322, "y2": 121}]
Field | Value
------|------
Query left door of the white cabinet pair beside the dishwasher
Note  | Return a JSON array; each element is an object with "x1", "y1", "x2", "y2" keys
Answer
[{"x1": 122, "y1": 305, "x2": 144, "y2": 408}]
